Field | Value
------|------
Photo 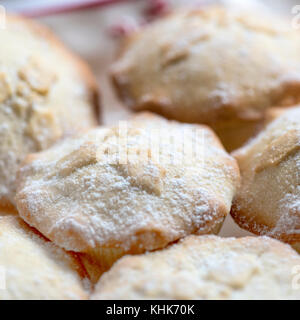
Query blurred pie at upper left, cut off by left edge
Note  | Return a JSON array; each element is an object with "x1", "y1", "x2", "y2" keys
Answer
[{"x1": 0, "y1": 16, "x2": 98, "y2": 209}]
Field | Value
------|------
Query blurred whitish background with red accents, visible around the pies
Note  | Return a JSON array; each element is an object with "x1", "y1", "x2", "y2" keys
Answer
[{"x1": 0, "y1": 0, "x2": 300, "y2": 236}]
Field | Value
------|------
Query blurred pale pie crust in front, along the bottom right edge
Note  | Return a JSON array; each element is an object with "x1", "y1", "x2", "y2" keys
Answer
[{"x1": 91, "y1": 236, "x2": 300, "y2": 300}]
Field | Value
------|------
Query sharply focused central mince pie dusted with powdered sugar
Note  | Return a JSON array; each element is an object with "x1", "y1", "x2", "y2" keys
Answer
[{"x1": 16, "y1": 114, "x2": 239, "y2": 280}]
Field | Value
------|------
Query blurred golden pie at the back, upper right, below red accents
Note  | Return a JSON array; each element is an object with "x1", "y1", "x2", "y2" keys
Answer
[{"x1": 112, "y1": 6, "x2": 300, "y2": 150}]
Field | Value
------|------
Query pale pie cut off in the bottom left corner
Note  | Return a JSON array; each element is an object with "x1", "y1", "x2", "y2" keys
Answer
[{"x1": 0, "y1": 215, "x2": 88, "y2": 300}]
